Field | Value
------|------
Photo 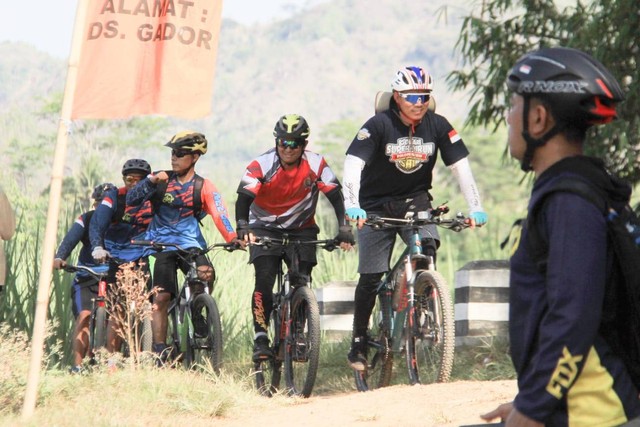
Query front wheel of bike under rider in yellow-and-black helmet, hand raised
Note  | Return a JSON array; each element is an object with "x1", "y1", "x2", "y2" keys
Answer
[{"x1": 189, "y1": 292, "x2": 222, "y2": 373}]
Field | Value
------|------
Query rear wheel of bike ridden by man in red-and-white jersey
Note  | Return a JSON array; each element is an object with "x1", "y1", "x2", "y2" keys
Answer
[{"x1": 254, "y1": 306, "x2": 284, "y2": 397}]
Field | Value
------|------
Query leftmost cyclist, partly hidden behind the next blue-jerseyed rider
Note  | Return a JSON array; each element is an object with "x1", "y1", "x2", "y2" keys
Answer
[{"x1": 53, "y1": 183, "x2": 117, "y2": 374}]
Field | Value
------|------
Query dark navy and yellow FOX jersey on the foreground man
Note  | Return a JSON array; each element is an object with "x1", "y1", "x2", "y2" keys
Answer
[{"x1": 509, "y1": 156, "x2": 640, "y2": 426}]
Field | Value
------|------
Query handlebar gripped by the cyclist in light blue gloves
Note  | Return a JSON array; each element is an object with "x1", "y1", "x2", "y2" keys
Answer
[{"x1": 365, "y1": 205, "x2": 471, "y2": 232}]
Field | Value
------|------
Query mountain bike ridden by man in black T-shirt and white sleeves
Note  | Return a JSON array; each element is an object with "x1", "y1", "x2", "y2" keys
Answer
[{"x1": 354, "y1": 205, "x2": 469, "y2": 391}]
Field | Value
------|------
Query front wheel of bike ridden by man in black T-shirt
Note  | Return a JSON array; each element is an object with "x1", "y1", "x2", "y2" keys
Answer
[{"x1": 406, "y1": 270, "x2": 455, "y2": 384}]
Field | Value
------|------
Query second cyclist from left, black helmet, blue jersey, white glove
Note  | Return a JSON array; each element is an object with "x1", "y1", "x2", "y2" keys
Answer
[{"x1": 89, "y1": 159, "x2": 152, "y2": 352}]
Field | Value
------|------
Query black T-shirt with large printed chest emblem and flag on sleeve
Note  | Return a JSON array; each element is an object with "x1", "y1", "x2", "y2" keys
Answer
[{"x1": 347, "y1": 105, "x2": 469, "y2": 210}]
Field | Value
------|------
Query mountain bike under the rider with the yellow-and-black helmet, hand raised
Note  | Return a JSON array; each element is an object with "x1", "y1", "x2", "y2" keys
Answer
[{"x1": 131, "y1": 240, "x2": 239, "y2": 373}]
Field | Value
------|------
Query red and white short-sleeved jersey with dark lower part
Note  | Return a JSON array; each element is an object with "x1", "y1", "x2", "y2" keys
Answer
[{"x1": 238, "y1": 148, "x2": 340, "y2": 230}]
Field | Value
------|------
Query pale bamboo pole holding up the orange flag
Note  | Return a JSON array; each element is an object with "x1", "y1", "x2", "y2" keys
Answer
[{"x1": 22, "y1": 0, "x2": 90, "y2": 420}]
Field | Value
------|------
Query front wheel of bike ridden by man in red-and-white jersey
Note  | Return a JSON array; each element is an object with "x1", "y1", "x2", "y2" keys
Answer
[{"x1": 284, "y1": 286, "x2": 320, "y2": 397}]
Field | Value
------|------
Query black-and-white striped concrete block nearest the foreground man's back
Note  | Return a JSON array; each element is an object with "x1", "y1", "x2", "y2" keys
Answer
[{"x1": 454, "y1": 260, "x2": 509, "y2": 346}]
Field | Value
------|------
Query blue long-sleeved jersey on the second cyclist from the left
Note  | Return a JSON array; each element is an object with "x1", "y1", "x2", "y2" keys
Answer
[{"x1": 89, "y1": 187, "x2": 153, "y2": 261}]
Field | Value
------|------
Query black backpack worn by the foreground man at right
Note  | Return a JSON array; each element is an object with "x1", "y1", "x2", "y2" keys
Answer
[{"x1": 526, "y1": 176, "x2": 640, "y2": 389}]
